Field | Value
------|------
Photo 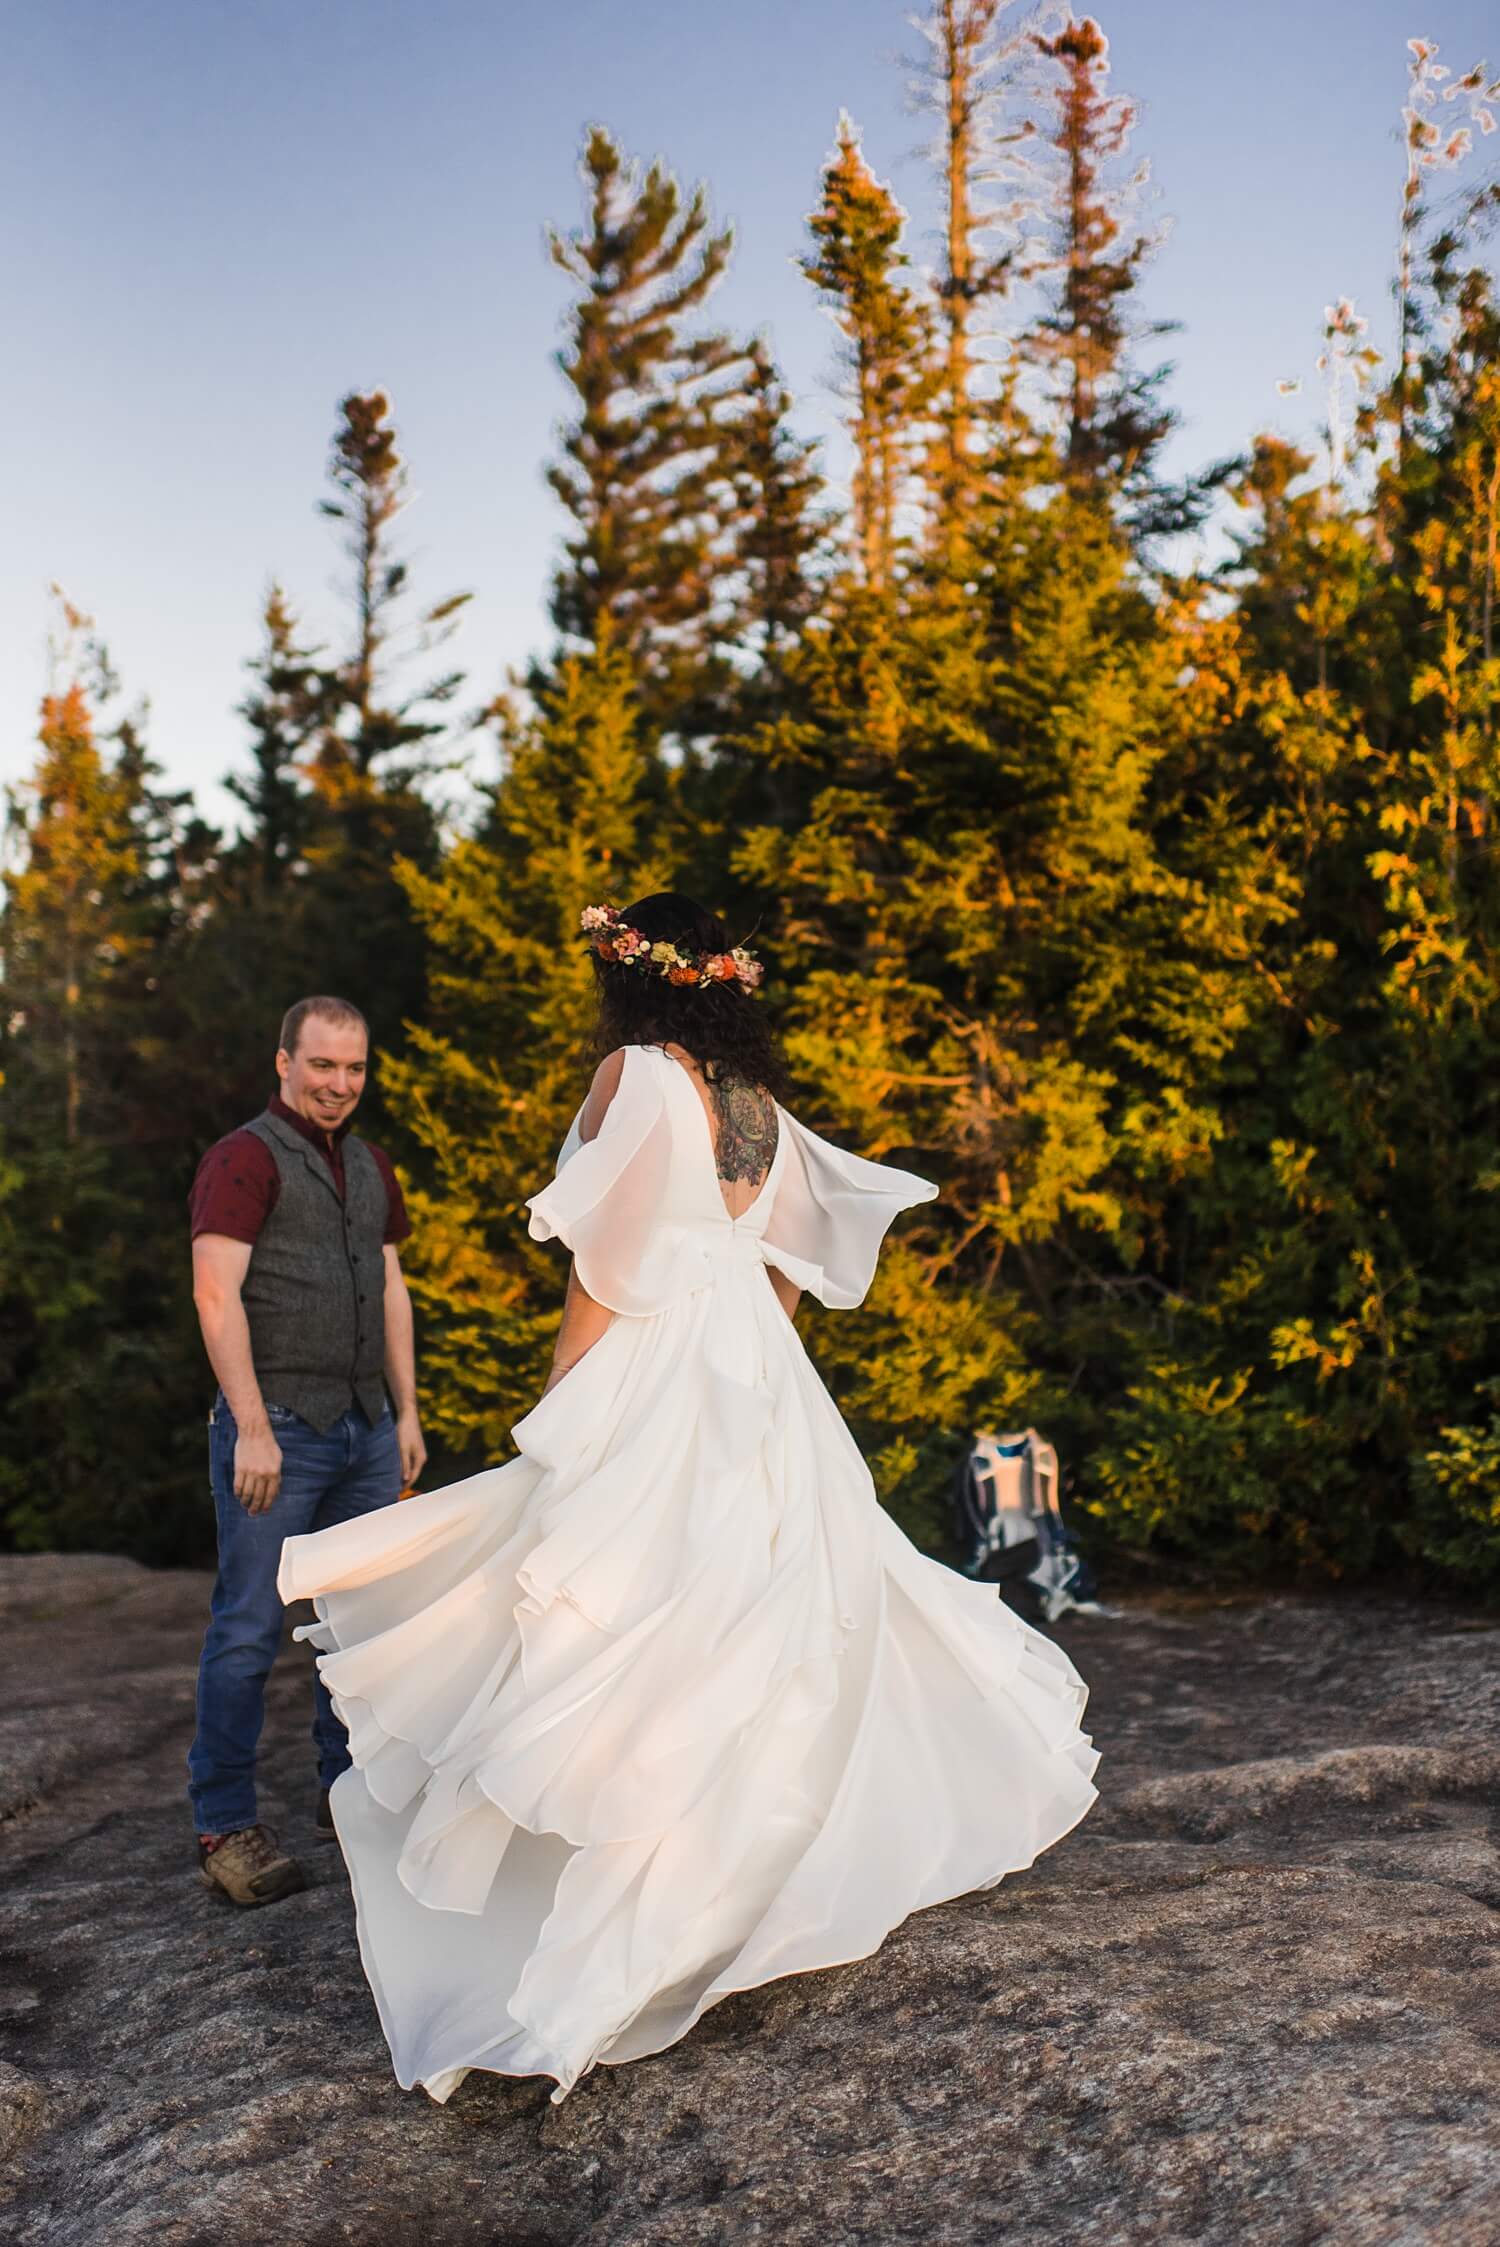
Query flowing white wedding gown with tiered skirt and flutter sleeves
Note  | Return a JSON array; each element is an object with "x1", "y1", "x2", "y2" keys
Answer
[{"x1": 281, "y1": 1047, "x2": 1096, "y2": 2099}]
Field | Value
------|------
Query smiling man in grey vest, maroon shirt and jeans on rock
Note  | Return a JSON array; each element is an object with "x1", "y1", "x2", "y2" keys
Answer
[{"x1": 189, "y1": 998, "x2": 427, "y2": 1905}]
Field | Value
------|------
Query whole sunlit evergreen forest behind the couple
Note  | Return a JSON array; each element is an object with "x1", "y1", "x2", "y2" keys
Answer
[{"x1": 0, "y1": 17, "x2": 1500, "y2": 1598}]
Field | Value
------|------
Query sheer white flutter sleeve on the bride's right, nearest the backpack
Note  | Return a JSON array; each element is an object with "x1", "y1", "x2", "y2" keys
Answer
[{"x1": 763, "y1": 1110, "x2": 939, "y2": 1310}]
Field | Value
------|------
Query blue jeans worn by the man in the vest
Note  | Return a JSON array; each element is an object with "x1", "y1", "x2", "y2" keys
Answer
[{"x1": 189, "y1": 1391, "x2": 402, "y2": 1834}]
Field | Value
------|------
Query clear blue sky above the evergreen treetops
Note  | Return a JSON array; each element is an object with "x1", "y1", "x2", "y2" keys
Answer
[{"x1": 0, "y1": 0, "x2": 1500, "y2": 816}]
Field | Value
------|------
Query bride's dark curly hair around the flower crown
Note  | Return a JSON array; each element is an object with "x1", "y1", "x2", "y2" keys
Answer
[{"x1": 593, "y1": 890, "x2": 790, "y2": 1099}]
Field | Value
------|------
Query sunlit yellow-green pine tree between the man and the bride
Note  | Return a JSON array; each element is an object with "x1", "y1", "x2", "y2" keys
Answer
[{"x1": 375, "y1": 642, "x2": 665, "y2": 1458}]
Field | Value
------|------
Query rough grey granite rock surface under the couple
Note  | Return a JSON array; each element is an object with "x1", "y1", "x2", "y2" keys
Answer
[{"x1": 0, "y1": 1557, "x2": 1500, "y2": 2247}]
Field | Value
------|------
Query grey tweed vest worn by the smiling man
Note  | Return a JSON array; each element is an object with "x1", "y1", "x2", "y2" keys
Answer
[{"x1": 240, "y1": 1110, "x2": 386, "y2": 1434}]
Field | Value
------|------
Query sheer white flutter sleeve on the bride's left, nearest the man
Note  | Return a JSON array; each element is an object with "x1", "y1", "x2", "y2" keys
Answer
[{"x1": 525, "y1": 1045, "x2": 710, "y2": 1319}]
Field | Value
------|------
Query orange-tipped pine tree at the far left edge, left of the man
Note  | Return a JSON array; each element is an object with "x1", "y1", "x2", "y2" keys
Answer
[{"x1": 0, "y1": 609, "x2": 200, "y2": 1559}]
